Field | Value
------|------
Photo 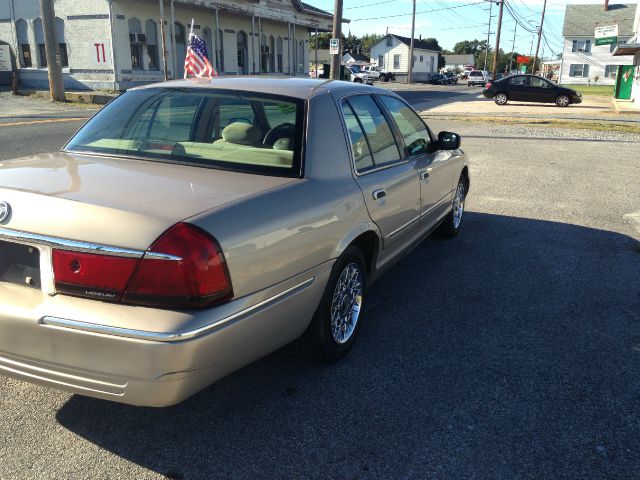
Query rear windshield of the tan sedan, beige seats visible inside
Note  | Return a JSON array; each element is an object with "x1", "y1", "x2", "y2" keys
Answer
[{"x1": 64, "y1": 88, "x2": 303, "y2": 176}]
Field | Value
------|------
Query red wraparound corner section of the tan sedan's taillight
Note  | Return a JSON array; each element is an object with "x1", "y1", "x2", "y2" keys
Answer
[{"x1": 122, "y1": 223, "x2": 231, "y2": 307}]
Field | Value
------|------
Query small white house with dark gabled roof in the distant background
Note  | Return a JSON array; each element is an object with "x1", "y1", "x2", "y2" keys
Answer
[{"x1": 370, "y1": 34, "x2": 439, "y2": 82}]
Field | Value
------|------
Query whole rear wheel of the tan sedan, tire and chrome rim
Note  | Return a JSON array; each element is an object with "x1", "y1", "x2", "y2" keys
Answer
[{"x1": 298, "y1": 246, "x2": 367, "y2": 363}]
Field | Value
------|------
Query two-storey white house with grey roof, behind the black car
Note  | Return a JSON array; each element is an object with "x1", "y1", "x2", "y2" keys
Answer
[{"x1": 558, "y1": 0, "x2": 636, "y2": 85}]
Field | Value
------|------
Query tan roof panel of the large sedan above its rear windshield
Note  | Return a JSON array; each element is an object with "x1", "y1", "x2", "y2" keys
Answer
[{"x1": 130, "y1": 75, "x2": 380, "y2": 99}]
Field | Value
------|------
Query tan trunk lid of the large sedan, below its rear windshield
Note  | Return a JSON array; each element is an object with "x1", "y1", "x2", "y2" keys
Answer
[{"x1": 0, "y1": 152, "x2": 295, "y2": 250}]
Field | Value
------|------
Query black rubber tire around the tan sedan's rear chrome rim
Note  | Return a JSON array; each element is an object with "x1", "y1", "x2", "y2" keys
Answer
[{"x1": 297, "y1": 246, "x2": 367, "y2": 363}]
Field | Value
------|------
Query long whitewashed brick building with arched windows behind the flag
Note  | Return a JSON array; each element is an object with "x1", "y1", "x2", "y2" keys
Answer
[{"x1": 0, "y1": 0, "x2": 333, "y2": 90}]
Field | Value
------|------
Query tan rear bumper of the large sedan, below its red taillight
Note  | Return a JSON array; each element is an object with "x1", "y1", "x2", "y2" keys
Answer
[{"x1": 0, "y1": 266, "x2": 330, "y2": 407}]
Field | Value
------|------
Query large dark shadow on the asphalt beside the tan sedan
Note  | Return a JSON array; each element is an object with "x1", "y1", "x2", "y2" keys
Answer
[{"x1": 57, "y1": 212, "x2": 640, "y2": 479}]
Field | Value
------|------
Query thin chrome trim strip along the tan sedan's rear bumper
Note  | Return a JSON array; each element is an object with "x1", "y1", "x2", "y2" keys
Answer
[{"x1": 40, "y1": 277, "x2": 316, "y2": 342}]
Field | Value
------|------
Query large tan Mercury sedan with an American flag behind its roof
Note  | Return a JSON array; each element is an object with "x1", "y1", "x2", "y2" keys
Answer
[{"x1": 0, "y1": 77, "x2": 469, "y2": 406}]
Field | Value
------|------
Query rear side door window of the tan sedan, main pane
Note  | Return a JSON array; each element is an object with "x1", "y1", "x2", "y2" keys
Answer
[{"x1": 346, "y1": 95, "x2": 401, "y2": 167}]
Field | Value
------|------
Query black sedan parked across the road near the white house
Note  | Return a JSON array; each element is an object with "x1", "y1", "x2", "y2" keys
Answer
[{"x1": 482, "y1": 75, "x2": 582, "y2": 107}]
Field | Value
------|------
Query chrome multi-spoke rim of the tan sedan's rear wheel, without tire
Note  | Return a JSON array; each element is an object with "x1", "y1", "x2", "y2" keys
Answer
[{"x1": 331, "y1": 263, "x2": 364, "y2": 344}]
